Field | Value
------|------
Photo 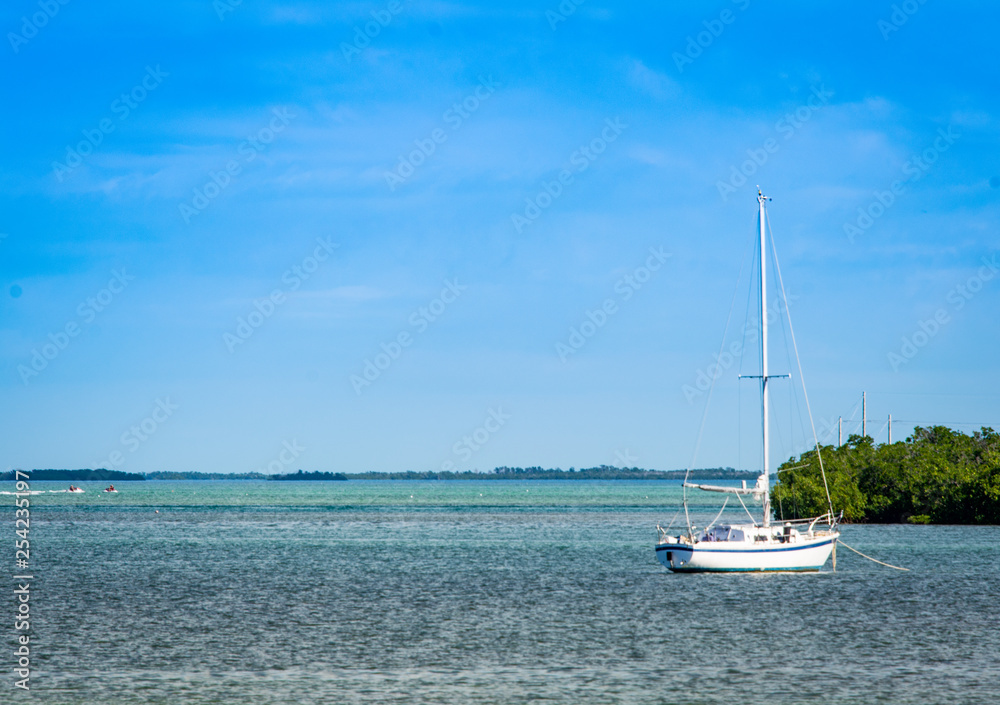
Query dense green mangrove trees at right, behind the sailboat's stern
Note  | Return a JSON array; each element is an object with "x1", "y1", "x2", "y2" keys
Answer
[{"x1": 771, "y1": 426, "x2": 1000, "y2": 524}]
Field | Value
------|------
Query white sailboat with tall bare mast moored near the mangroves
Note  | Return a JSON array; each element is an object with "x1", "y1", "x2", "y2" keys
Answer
[{"x1": 656, "y1": 189, "x2": 840, "y2": 573}]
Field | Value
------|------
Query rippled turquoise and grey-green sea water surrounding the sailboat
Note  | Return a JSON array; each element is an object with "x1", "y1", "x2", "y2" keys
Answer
[{"x1": 15, "y1": 481, "x2": 1000, "y2": 705}]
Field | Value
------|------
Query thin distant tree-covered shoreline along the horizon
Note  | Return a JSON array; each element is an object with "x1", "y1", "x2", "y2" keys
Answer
[{"x1": 2, "y1": 465, "x2": 758, "y2": 482}]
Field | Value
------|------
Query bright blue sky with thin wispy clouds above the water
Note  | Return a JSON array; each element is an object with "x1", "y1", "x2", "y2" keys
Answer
[{"x1": 0, "y1": 0, "x2": 1000, "y2": 472}]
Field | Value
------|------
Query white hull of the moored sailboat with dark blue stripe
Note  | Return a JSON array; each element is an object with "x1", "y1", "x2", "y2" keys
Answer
[{"x1": 656, "y1": 533, "x2": 840, "y2": 573}]
